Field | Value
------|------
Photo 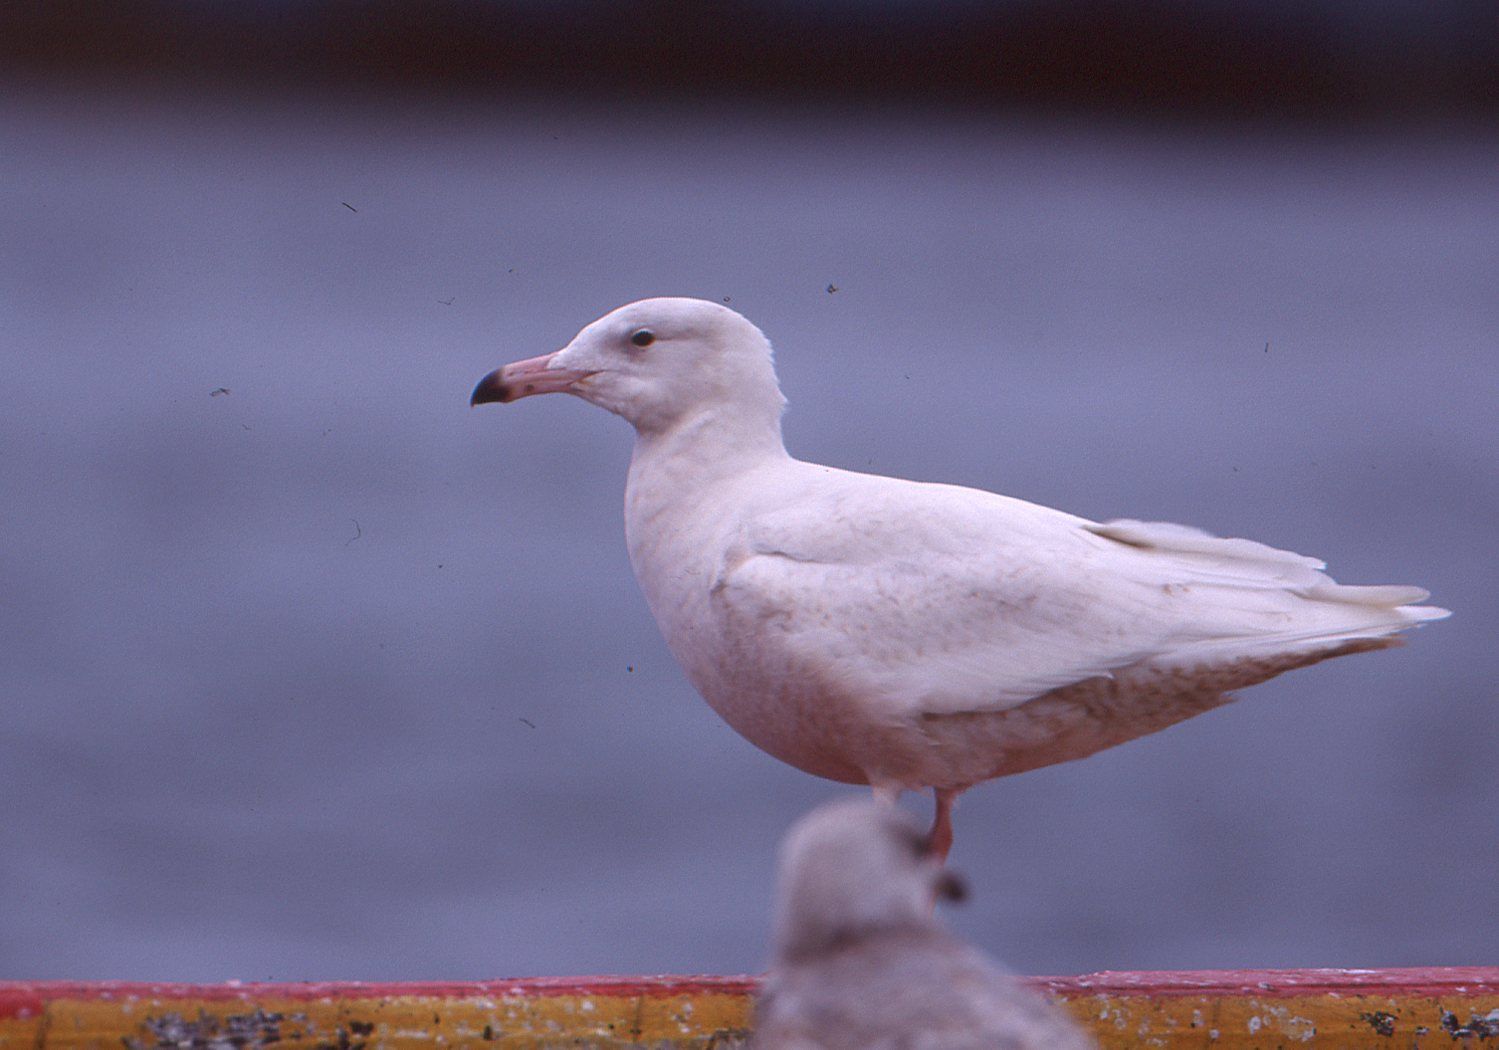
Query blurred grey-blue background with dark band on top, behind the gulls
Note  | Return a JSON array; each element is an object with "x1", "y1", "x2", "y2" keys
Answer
[{"x1": 0, "y1": 0, "x2": 1499, "y2": 981}]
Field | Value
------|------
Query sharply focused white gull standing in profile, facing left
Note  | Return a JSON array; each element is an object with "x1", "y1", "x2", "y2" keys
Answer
[{"x1": 472, "y1": 299, "x2": 1447, "y2": 857}]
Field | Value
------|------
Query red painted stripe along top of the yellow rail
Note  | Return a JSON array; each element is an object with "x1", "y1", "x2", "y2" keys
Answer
[{"x1": 0, "y1": 966, "x2": 1499, "y2": 1019}]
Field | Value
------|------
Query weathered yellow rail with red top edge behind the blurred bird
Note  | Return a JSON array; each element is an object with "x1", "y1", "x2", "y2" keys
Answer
[{"x1": 0, "y1": 968, "x2": 1499, "y2": 1050}]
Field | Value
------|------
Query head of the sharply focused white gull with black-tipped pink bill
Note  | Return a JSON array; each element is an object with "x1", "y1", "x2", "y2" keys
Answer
[{"x1": 469, "y1": 299, "x2": 785, "y2": 432}]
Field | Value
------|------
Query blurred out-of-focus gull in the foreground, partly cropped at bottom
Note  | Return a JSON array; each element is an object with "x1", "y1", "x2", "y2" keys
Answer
[{"x1": 751, "y1": 801, "x2": 1094, "y2": 1050}]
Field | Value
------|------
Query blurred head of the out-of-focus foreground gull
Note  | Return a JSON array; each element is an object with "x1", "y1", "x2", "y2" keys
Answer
[{"x1": 775, "y1": 800, "x2": 964, "y2": 960}]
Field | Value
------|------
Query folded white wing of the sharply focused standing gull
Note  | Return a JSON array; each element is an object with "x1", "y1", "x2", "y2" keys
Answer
[{"x1": 712, "y1": 468, "x2": 1447, "y2": 716}]
